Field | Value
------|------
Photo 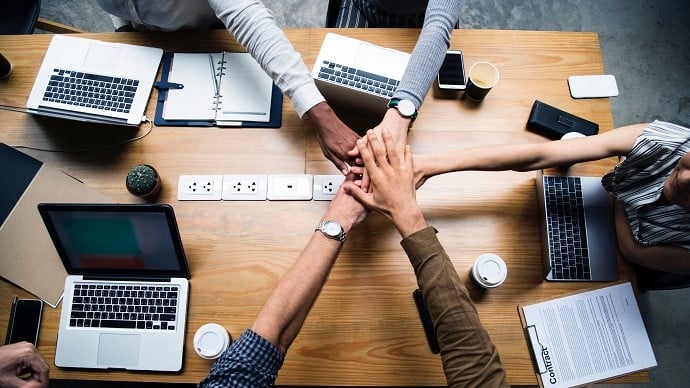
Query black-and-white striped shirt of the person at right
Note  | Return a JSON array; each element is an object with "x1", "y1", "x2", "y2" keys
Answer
[{"x1": 602, "y1": 121, "x2": 690, "y2": 251}]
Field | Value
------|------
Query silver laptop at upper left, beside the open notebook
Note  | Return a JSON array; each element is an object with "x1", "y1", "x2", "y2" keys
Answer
[{"x1": 27, "y1": 35, "x2": 163, "y2": 125}]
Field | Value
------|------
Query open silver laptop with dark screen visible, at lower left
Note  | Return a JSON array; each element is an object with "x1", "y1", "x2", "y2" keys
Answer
[{"x1": 38, "y1": 203, "x2": 189, "y2": 372}]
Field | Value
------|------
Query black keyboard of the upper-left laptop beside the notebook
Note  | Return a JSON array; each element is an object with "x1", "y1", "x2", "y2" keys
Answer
[{"x1": 43, "y1": 69, "x2": 139, "y2": 113}]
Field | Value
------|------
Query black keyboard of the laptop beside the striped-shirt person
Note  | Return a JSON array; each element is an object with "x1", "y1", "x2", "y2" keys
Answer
[{"x1": 544, "y1": 176, "x2": 592, "y2": 280}]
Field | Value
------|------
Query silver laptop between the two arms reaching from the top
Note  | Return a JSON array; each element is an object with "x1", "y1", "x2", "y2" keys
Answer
[{"x1": 311, "y1": 33, "x2": 410, "y2": 114}]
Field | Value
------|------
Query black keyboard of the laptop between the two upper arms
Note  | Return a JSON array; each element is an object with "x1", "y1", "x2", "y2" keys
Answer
[{"x1": 318, "y1": 61, "x2": 400, "y2": 98}]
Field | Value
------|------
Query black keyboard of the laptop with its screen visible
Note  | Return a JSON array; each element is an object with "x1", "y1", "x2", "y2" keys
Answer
[{"x1": 69, "y1": 283, "x2": 179, "y2": 330}]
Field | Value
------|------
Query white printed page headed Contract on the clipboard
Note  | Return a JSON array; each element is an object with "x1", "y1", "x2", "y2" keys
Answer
[{"x1": 518, "y1": 282, "x2": 657, "y2": 388}]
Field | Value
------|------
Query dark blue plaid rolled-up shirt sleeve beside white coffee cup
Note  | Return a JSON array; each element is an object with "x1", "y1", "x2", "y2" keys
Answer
[{"x1": 199, "y1": 329, "x2": 285, "y2": 388}]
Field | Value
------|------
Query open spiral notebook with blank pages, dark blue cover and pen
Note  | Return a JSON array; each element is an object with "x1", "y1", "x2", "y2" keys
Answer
[{"x1": 154, "y1": 52, "x2": 282, "y2": 128}]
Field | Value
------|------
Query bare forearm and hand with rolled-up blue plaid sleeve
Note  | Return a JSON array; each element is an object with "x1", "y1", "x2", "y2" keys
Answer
[{"x1": 199, "y1": 177, "x2": 366, "y2": 387}]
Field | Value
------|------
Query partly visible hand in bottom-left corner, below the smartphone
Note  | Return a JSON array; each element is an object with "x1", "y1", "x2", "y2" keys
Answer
[{"x1": 0, "y1": 342, "x2": 50, "y2": 388}]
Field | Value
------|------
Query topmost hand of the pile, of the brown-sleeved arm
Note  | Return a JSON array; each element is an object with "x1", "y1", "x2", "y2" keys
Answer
[{"x1": 343, "y1": 128, "x2": 426, "y2": 238}]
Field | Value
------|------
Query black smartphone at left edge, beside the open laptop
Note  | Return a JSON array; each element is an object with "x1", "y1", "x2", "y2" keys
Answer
[{"x1": 5, "y1": 298, "x2": 43, "y2": 346}]
